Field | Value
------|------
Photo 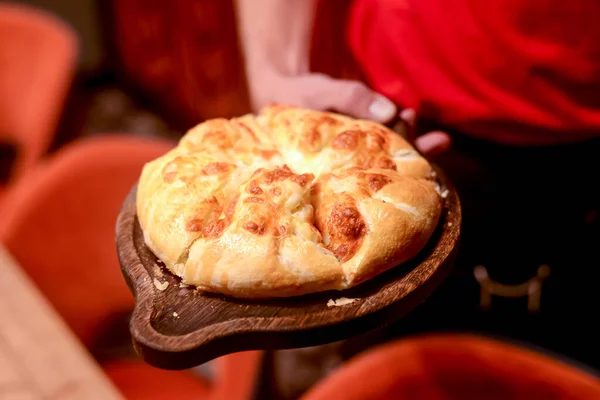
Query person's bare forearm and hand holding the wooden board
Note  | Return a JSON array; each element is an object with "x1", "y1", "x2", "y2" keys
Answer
[{"x1": 235, "y1": 0, "x2": 450, "y2": 157}]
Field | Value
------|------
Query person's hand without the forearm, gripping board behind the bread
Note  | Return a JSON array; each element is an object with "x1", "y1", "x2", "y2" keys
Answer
[{"x1": 249, "y1": 69, "x2": 450, "y2": 157}]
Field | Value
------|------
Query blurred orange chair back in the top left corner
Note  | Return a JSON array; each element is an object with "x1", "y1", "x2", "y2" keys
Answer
[{"x1": 0, "y1": 4, "x2": 79, "y2": 190}]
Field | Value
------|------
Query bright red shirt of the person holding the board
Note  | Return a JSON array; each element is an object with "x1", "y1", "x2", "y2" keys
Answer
[{"x1": 348, "y1": 0, "x2": 600, "y2": 145}]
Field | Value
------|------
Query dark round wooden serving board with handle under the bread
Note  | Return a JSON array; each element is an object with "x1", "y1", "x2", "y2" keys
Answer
[{"x1": 117, "y1": 170, "x2": 461, "y2": 369}]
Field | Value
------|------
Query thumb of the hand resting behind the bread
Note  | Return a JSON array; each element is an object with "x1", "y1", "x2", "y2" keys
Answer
[{"x1": 298, "y1": 74, "x2": 397, "y2": 123}]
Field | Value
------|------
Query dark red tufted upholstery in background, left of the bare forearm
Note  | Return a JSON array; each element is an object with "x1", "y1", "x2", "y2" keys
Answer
[{"x1": 110, "y1": 0, "x2": 248, "y2": 126}]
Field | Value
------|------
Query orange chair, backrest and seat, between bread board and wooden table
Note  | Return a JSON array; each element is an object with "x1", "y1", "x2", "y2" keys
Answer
[{"x1": 0, "y1": 135, "x2": 260, "y2": 400}]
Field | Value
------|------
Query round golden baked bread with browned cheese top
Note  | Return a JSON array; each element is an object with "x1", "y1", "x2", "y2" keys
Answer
[{"x1": 137, "y1": 105, "x2": 442, "y2": 298}]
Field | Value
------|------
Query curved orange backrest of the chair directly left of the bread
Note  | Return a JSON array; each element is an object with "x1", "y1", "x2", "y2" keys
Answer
[{"x1": 0, "y1": 135, "x2": 175, "y2": 346}]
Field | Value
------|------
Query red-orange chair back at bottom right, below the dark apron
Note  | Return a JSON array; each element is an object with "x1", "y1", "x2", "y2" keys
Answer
[{"x1": 303, "y1": 334, "x2": 600, "y2": 400}]
